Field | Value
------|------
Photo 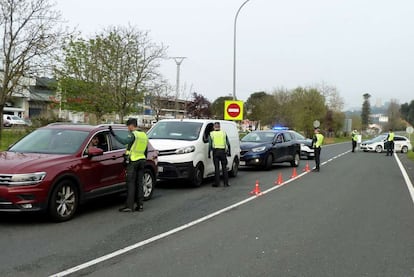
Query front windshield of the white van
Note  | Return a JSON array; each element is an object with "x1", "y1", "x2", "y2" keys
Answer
[{"x1": 148, "y1": 121, "x2": 203, "y2": 140}]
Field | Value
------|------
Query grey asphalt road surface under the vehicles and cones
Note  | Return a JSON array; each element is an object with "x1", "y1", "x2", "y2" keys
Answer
[{"x1": 0, "y1": 144, "x2": 414, "y2": 276}]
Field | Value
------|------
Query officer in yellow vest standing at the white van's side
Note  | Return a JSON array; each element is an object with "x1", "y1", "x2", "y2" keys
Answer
[{"x1": 208, "y1": 122, "x2": 231, "y2": 187}]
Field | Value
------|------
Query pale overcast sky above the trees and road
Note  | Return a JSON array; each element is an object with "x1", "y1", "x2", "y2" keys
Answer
[{"x1": 57, "y1": 0, "x2": 414, "y2": 108}]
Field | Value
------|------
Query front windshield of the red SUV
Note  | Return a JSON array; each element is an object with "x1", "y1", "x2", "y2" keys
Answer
[{"x1": 9, "y1": 129, "x2": 89, "y2": 154}]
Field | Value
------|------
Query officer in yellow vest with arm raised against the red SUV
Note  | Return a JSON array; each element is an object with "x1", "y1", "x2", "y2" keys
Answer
[{"x1": 109, "y1": 118, "x2": 148, "y2": 212}]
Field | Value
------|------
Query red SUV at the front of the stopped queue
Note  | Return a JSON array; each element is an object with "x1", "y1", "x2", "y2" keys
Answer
[{"x1": 0, "y1": 123, "x2": 158, "y2": 221}]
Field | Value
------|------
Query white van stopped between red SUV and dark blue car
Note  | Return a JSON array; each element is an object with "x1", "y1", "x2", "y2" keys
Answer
[{"x1": 148, "y1": 119, "x2": 240, "y2": 186}]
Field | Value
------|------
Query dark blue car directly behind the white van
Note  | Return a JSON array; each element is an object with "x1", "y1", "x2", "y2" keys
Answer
[{"x1": 240, "y1": 130, "x2": 301, "y2": 169}]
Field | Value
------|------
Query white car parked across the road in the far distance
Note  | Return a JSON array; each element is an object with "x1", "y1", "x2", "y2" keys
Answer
[{"x1": 360, "y1": 134, "x2": 413, "y2": 153}]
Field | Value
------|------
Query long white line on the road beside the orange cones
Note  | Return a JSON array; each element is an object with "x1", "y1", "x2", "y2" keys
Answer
[{"x1": 49, "y1": 150, "x2": 350, "y2": 277}]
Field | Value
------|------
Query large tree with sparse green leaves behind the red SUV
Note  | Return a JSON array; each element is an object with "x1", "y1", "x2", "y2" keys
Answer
[{"x1": 56, "y1": 26, "x2": 166, "y2": 121}]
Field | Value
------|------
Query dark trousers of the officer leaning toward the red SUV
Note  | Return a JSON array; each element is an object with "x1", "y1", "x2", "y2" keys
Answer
[{"x1": 126, "y1": 159, "x2": 145, "y2": 210}]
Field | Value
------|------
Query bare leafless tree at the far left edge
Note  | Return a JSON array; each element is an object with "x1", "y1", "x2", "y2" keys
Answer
[{"x1": 0, "y1": 0, "x2": 65, "y2": 134}]
